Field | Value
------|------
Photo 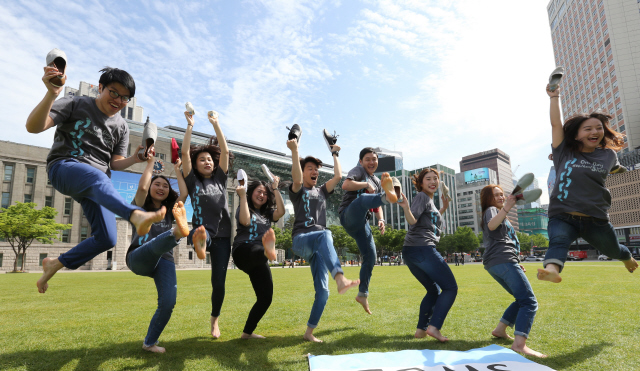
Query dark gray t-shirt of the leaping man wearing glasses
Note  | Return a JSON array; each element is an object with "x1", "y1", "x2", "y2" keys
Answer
[{"x1": 47, "y1": 96, "x2": 129, "y2": 177}]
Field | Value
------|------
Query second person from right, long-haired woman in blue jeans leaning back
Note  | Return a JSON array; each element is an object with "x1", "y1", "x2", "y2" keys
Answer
[{"x1": 480, "y1": 184, "x2": 546, "y2": 357}]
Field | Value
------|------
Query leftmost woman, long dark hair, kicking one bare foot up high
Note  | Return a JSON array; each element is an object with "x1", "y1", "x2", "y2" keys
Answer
[{"x1": 126, "y1": 154, "x2": 205, "y2": 353}]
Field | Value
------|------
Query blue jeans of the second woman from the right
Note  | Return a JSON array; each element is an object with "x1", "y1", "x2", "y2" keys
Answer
[{"x1": 487, "y1": 263, "x2": 538, "y2": 338}]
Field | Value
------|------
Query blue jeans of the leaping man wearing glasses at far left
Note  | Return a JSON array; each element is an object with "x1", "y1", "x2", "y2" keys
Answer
[{"x1": 48, "y1": 159, "x2": 142, "y2": 269}]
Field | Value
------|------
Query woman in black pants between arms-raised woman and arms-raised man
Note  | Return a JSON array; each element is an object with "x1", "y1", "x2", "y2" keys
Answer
[{"x1": 231, "y1": 176, "x2": 285, "y2": 339}]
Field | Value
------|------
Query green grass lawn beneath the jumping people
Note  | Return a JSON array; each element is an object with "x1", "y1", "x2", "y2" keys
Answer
[{"x1": 0, "y1": 262, "x2": 640, "y2": 370}]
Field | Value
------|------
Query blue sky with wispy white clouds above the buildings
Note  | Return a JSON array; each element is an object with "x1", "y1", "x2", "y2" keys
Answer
[{"x1": 0, "y1": 0, "x2": 555, "y2": 201}]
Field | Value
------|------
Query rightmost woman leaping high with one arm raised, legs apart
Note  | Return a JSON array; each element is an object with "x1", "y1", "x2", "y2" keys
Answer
[{"x1": 538, "y1": 85, "x2": 638, "y2": 283}]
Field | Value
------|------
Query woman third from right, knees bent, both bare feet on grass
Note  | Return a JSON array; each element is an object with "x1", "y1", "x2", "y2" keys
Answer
[{"x1": 398, "y1": 168, "x2": 458, "y2": 342}]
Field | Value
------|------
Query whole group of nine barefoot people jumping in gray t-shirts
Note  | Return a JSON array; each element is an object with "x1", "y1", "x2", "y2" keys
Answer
[{"x1": 26, "y1": 65, "x2": 638, "y2": 357}]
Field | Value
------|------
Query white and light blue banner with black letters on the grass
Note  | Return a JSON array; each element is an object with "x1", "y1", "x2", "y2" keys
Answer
[{"x1": 309, "y1": 345, "x2": 554, "y2": 371}]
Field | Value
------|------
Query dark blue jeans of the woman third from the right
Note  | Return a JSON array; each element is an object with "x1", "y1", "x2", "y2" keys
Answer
[{"x1": 402, "y1": 246, "x2": 458, "y2": 330}]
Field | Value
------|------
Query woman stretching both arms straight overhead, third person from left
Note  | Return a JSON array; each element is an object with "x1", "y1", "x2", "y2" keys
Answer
[{"x1": 182, "y1": 111, "x2": 233, "y2": 339}]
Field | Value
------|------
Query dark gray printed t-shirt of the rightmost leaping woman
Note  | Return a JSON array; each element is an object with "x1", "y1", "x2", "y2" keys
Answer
[{"x1": 549, "y1": 140, "x2": 620, "y2": 219}]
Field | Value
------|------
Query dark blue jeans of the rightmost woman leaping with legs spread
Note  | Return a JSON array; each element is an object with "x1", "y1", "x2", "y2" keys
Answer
[{"x1": 543, "y1": 213, "x2": 631, "y2": 272}]
